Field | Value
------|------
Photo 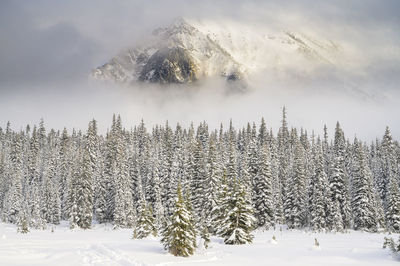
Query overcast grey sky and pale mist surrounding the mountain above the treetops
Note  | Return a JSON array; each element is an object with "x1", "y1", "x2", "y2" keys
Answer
[{"x1": 0, "y1": 0, "x2": 400, "y2": 139}]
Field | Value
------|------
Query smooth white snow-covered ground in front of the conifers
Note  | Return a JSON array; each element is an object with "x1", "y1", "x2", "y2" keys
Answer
[{"x1": 0, "y1": 223, "x2": 399, "y2": 266}]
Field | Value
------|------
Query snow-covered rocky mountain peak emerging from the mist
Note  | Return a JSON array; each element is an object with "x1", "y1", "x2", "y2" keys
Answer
[{"x1": 92, "y1": 19, "x2": 341, "y2": 84}]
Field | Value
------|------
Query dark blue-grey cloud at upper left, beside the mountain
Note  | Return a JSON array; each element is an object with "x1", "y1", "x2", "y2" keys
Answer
[{"x1": 0, "y1": 2, "x2": 96, "y2": 90}]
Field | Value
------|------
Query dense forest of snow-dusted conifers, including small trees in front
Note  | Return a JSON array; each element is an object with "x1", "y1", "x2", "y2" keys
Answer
[{"x1": 0, "y1": 109, "x2": 400, "y2": 256}]
